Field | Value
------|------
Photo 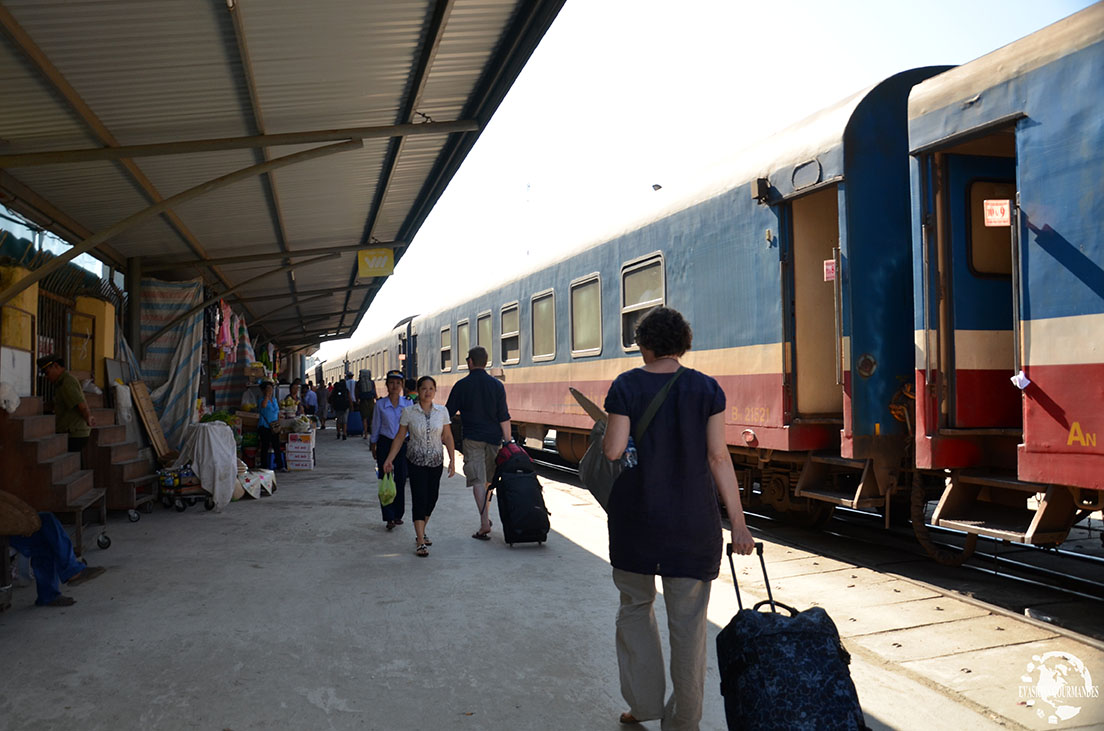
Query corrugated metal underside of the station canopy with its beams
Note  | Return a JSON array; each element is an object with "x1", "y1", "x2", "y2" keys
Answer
[{"x1": 0, "y1": 0, "x2": 563, "y2": 348}]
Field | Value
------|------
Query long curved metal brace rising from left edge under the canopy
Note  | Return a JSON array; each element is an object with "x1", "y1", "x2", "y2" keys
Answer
[{"x1": 0, "y1": 139, "x2": 363, "y2": 305}]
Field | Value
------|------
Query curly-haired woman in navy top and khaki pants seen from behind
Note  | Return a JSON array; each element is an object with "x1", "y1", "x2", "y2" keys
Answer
[{"x1": 603, "y1": 307, "x2": 754, "y2": 731}]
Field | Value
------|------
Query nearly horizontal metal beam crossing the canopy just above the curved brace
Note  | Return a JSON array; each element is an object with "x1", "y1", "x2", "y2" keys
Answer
[{"x1": 0, "y1": 120, "x2": 479, "y2": 168}]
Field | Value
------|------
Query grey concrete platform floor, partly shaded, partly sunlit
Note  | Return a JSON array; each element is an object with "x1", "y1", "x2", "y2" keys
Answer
[{"x1": 0, "y1": 437, "x2": 1104, "y2": 731}]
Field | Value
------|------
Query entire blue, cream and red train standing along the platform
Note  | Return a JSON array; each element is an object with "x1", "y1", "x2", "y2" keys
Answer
[{"x1": 347, "y1": 4, "x2": 1104, "y2": 561}]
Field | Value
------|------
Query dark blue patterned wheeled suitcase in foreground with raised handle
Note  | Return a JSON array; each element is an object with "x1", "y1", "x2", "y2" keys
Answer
[{"x1": 716, "y1": 543, "x2": 867, "y2": 731}]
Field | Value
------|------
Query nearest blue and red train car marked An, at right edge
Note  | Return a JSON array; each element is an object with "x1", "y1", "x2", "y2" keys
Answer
[{"x1": 909, "y1": 4, "x2": 1104, "y2": 543}]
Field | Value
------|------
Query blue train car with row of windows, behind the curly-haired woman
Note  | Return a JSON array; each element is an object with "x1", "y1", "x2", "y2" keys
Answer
[{"x1": 349, "y1": 67, "x2": 945, "y2": 527}]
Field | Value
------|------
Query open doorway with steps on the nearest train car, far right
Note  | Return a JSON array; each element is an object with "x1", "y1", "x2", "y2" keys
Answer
[{"x1": 930, "y1": 124, "x2": 1074, "y2": 544}]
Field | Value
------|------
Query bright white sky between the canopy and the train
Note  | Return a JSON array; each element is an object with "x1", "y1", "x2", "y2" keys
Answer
[{"x1": 318, "y1": 0, "x2": 1092, "y2": 360}]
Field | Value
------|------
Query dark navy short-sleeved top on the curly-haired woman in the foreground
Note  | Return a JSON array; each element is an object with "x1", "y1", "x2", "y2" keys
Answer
[{"x1": 605, "y1": 368, "x2": 724, "y2": 581}]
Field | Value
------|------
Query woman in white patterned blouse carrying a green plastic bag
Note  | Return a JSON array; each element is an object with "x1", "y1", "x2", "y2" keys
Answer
[{"x1": 383, "y1": 375, "x2": 456, "y2": 557}]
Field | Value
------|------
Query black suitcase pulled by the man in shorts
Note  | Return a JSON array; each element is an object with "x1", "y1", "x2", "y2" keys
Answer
[{"x1": 488, "y1": 443, "x2": 551, "y2": 547}]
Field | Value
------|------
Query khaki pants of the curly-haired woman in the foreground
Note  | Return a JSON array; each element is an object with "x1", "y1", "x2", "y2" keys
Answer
[{"x1": 614, "y1": 569, "x2": 710, "y2": 731}]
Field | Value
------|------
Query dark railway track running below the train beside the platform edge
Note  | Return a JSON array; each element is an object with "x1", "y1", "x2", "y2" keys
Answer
[{"x1": 528, "y1": 449, "x2": 1104, "y2": 639}]
